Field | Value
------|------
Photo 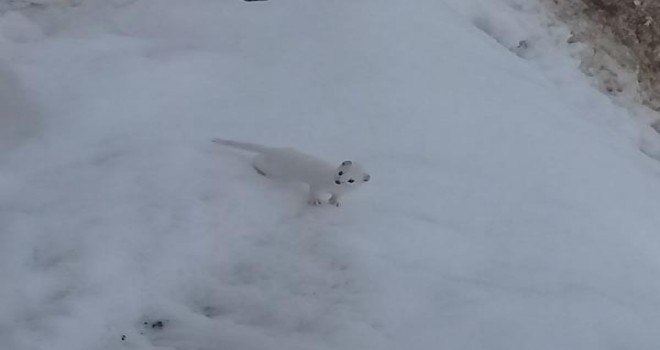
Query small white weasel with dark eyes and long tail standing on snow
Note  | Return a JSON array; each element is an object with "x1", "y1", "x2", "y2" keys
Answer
[{"x1": 213, "y1": 138, "x2": 371, "y2": 206}]
